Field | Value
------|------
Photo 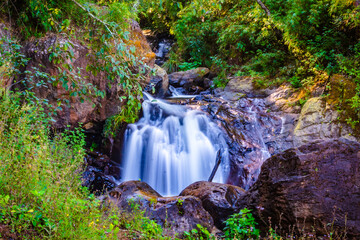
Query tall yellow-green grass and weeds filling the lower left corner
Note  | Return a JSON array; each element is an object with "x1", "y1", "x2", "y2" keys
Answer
[{"x1": 0, "y1": 89, "x2": 167, "y2": 239}]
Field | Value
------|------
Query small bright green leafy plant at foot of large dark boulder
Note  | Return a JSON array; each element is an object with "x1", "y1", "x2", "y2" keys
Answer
[{"x1": 224, "y1": 208, "x2": 260, "y2": 239}]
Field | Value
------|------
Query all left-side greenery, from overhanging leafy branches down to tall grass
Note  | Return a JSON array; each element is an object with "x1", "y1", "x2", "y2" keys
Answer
[{"x1": 0, "y1": 0, "x2": 163, "y2": 239}]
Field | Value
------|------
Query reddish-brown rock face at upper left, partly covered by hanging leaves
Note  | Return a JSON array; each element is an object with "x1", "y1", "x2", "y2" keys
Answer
[{"x1": 24, "y1": 35, "x2": 121, "y2": 128}]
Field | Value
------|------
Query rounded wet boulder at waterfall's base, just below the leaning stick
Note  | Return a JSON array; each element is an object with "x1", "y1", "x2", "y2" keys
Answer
[{"x1": 180, "y1": 181, "x2": 245, "y2": 229}]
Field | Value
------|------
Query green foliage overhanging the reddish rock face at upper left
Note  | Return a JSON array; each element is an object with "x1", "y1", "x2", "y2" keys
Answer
[{"x1": 0, "y1": 0, "x2": 147, "y2": 133}]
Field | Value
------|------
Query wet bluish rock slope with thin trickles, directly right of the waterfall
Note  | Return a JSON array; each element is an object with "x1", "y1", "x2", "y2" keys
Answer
[{"x1": 194, "y1": 96, "x2": 297, "y2": 189}]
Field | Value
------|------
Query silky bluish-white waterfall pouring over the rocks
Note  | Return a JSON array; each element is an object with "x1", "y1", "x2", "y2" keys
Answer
[{"x1": 121, "y1": 94, "x2": 229, "y2": 196}]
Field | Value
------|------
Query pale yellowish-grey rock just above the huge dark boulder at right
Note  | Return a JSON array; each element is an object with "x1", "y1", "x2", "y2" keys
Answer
[{"x1": 294, "y1": 97, "x2": 357, "y2": 146}]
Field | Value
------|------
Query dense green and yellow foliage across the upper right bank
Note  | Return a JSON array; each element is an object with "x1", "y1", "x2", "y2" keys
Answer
[{"x1": 139, "y1": 0, "x2": 360, "y2": 125}]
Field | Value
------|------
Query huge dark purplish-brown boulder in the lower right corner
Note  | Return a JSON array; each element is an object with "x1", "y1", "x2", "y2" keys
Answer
[{"x1": 240, "y1": 139, "x2": 360, "y2": 239}]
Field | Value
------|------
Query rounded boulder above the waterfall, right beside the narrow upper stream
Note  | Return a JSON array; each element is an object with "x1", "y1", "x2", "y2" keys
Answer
[{"x1": 169, "y1": 67, "x2": 210, "y2": 91}]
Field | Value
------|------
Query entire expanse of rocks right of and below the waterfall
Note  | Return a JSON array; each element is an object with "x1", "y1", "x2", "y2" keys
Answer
[{"x1": 83, "y1": 62, "x2": 360, "y2": 238}]
